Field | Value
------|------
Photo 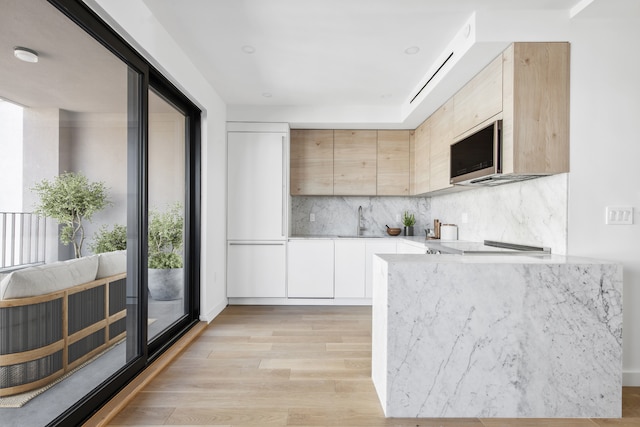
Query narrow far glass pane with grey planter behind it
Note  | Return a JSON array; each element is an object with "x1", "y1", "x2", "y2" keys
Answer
[{"x1": 148, "y1": 91, "x2": 187, "y2": 341}]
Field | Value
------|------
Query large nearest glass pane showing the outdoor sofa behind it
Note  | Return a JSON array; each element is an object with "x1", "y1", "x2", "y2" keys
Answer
[{"x1": 0, "y1": 0, "x2": 142, "y2": 426}]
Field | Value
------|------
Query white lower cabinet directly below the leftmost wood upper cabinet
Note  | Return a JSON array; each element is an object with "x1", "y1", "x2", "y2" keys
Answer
[{"x1": 287, "y1": 240, "x2": 334, "y2": 298}]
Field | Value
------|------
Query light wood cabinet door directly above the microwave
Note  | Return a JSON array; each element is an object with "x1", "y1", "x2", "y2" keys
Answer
[{"x1": 453, "y1": 55, "x2": 502, "y2": 136}]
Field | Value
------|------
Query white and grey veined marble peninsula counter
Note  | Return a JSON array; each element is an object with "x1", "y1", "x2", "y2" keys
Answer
[{"x1": 372, "y1": 255, "x2": 622, "y2": 418}]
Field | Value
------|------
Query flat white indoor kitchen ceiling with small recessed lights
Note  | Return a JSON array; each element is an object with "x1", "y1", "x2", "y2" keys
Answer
[{"x1": 144, "y1": 0, "x2": 584, "y2": 126}]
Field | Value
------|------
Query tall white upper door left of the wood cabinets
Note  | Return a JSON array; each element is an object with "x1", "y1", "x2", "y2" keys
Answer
[{"x1": 227, "y1": 132, "x2": 286, "y2": 240}]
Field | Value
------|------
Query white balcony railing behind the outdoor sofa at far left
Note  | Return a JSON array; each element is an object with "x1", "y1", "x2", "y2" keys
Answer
[{"x1": 0, "y1": 212, "x2": 47, "y2": 272}]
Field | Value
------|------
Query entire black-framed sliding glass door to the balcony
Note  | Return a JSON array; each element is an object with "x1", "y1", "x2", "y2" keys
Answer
[{"x1": 0, "y1": 0, "x2": 200, "y2": 427}]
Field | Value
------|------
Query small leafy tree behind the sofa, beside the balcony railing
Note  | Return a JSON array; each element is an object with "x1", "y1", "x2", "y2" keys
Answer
[{"x1": 32, "y1": 172, "x2": 111, "y2": 258}]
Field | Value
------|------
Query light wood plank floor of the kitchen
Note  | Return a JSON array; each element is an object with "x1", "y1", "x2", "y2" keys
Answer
[{"x1": 110, "y1": 306, "x2": 640, "y2": 427}]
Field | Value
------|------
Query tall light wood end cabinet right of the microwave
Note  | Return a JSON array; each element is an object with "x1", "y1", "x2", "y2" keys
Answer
[{"x1": 502, "y1": 43, "x2": 570, "y2": 174}]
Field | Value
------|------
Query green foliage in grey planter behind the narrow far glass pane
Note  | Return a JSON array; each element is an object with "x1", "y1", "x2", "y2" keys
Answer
[{"x1": 148, "y1": 203, "x2": 184, "y2": 268}]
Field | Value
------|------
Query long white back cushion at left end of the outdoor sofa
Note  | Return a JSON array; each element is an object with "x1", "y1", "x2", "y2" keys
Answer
[{"x1": 0, "y1": 255, "x2": 98, "y2": 300}]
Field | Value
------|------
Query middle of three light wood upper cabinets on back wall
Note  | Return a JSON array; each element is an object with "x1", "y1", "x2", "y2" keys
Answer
[{"x1": 333, "y1": 130, "x2": 378, "y2": 196}]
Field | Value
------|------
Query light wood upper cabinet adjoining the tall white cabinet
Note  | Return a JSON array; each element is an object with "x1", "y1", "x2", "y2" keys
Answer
[{"x1": 290, "y1": 129, "x2": 333, "y2": 196}]
